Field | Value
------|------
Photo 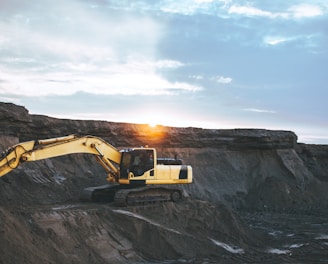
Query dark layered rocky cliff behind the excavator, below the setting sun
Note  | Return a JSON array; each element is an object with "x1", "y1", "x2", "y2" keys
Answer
[{"x1": 0, "y1": 103, "x2": 328, "y2": 210}]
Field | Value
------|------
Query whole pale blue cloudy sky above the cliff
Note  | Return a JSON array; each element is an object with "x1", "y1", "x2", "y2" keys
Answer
[{"x1": 0, "y1": 0, "x2": 328, "y2": 144}]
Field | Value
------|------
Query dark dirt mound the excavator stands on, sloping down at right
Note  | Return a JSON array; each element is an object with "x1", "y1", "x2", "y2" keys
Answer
[{"x1": 0, "y1": 200, "x2": 266, "y2": 263}]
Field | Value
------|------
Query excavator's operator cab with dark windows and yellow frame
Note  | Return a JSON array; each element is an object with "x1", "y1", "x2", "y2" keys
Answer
[{"x1": 120, "y1": 148, "x2": 156, "y2": 183}]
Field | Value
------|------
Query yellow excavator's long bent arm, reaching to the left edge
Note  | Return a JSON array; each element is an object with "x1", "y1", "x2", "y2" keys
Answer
[{"x1": 0, "y1": 135, "x2": 121, "y2": 182}]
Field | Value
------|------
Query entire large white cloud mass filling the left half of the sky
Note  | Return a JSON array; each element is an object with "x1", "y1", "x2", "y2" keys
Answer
[{"x1": 0, "y1": 1, "x2": 202, "y2": 96}]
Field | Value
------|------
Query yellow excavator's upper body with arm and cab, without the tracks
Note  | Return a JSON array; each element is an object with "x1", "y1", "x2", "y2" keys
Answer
[{"x1": 0, "y1": 135, "x2": 192, "y2": 184}]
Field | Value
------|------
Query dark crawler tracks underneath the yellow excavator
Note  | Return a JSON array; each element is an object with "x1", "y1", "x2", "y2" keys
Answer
[{"x1": 80, "y1": 184, "x2": 182, "y2": 206}]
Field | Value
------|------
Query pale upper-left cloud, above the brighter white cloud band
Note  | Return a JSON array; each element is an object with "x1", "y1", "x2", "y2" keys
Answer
[{"x1": 0, "y1": 5, "x2": 164, "y2": 60}]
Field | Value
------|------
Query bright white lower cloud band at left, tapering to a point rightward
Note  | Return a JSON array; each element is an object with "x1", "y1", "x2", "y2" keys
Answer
[{"x1": 0, "y1": 63, "x2": 202, "y2": 96}]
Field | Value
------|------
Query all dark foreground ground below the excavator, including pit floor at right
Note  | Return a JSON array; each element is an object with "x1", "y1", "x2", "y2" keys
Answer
[{"x1": 0, "y1": 200, "x2": 328, "y2": 264}]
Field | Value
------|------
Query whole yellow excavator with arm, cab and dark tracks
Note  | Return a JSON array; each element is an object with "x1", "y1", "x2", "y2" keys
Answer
[{"x1": 0, "y1": 135, "x2": 192, "y2": 206}]
